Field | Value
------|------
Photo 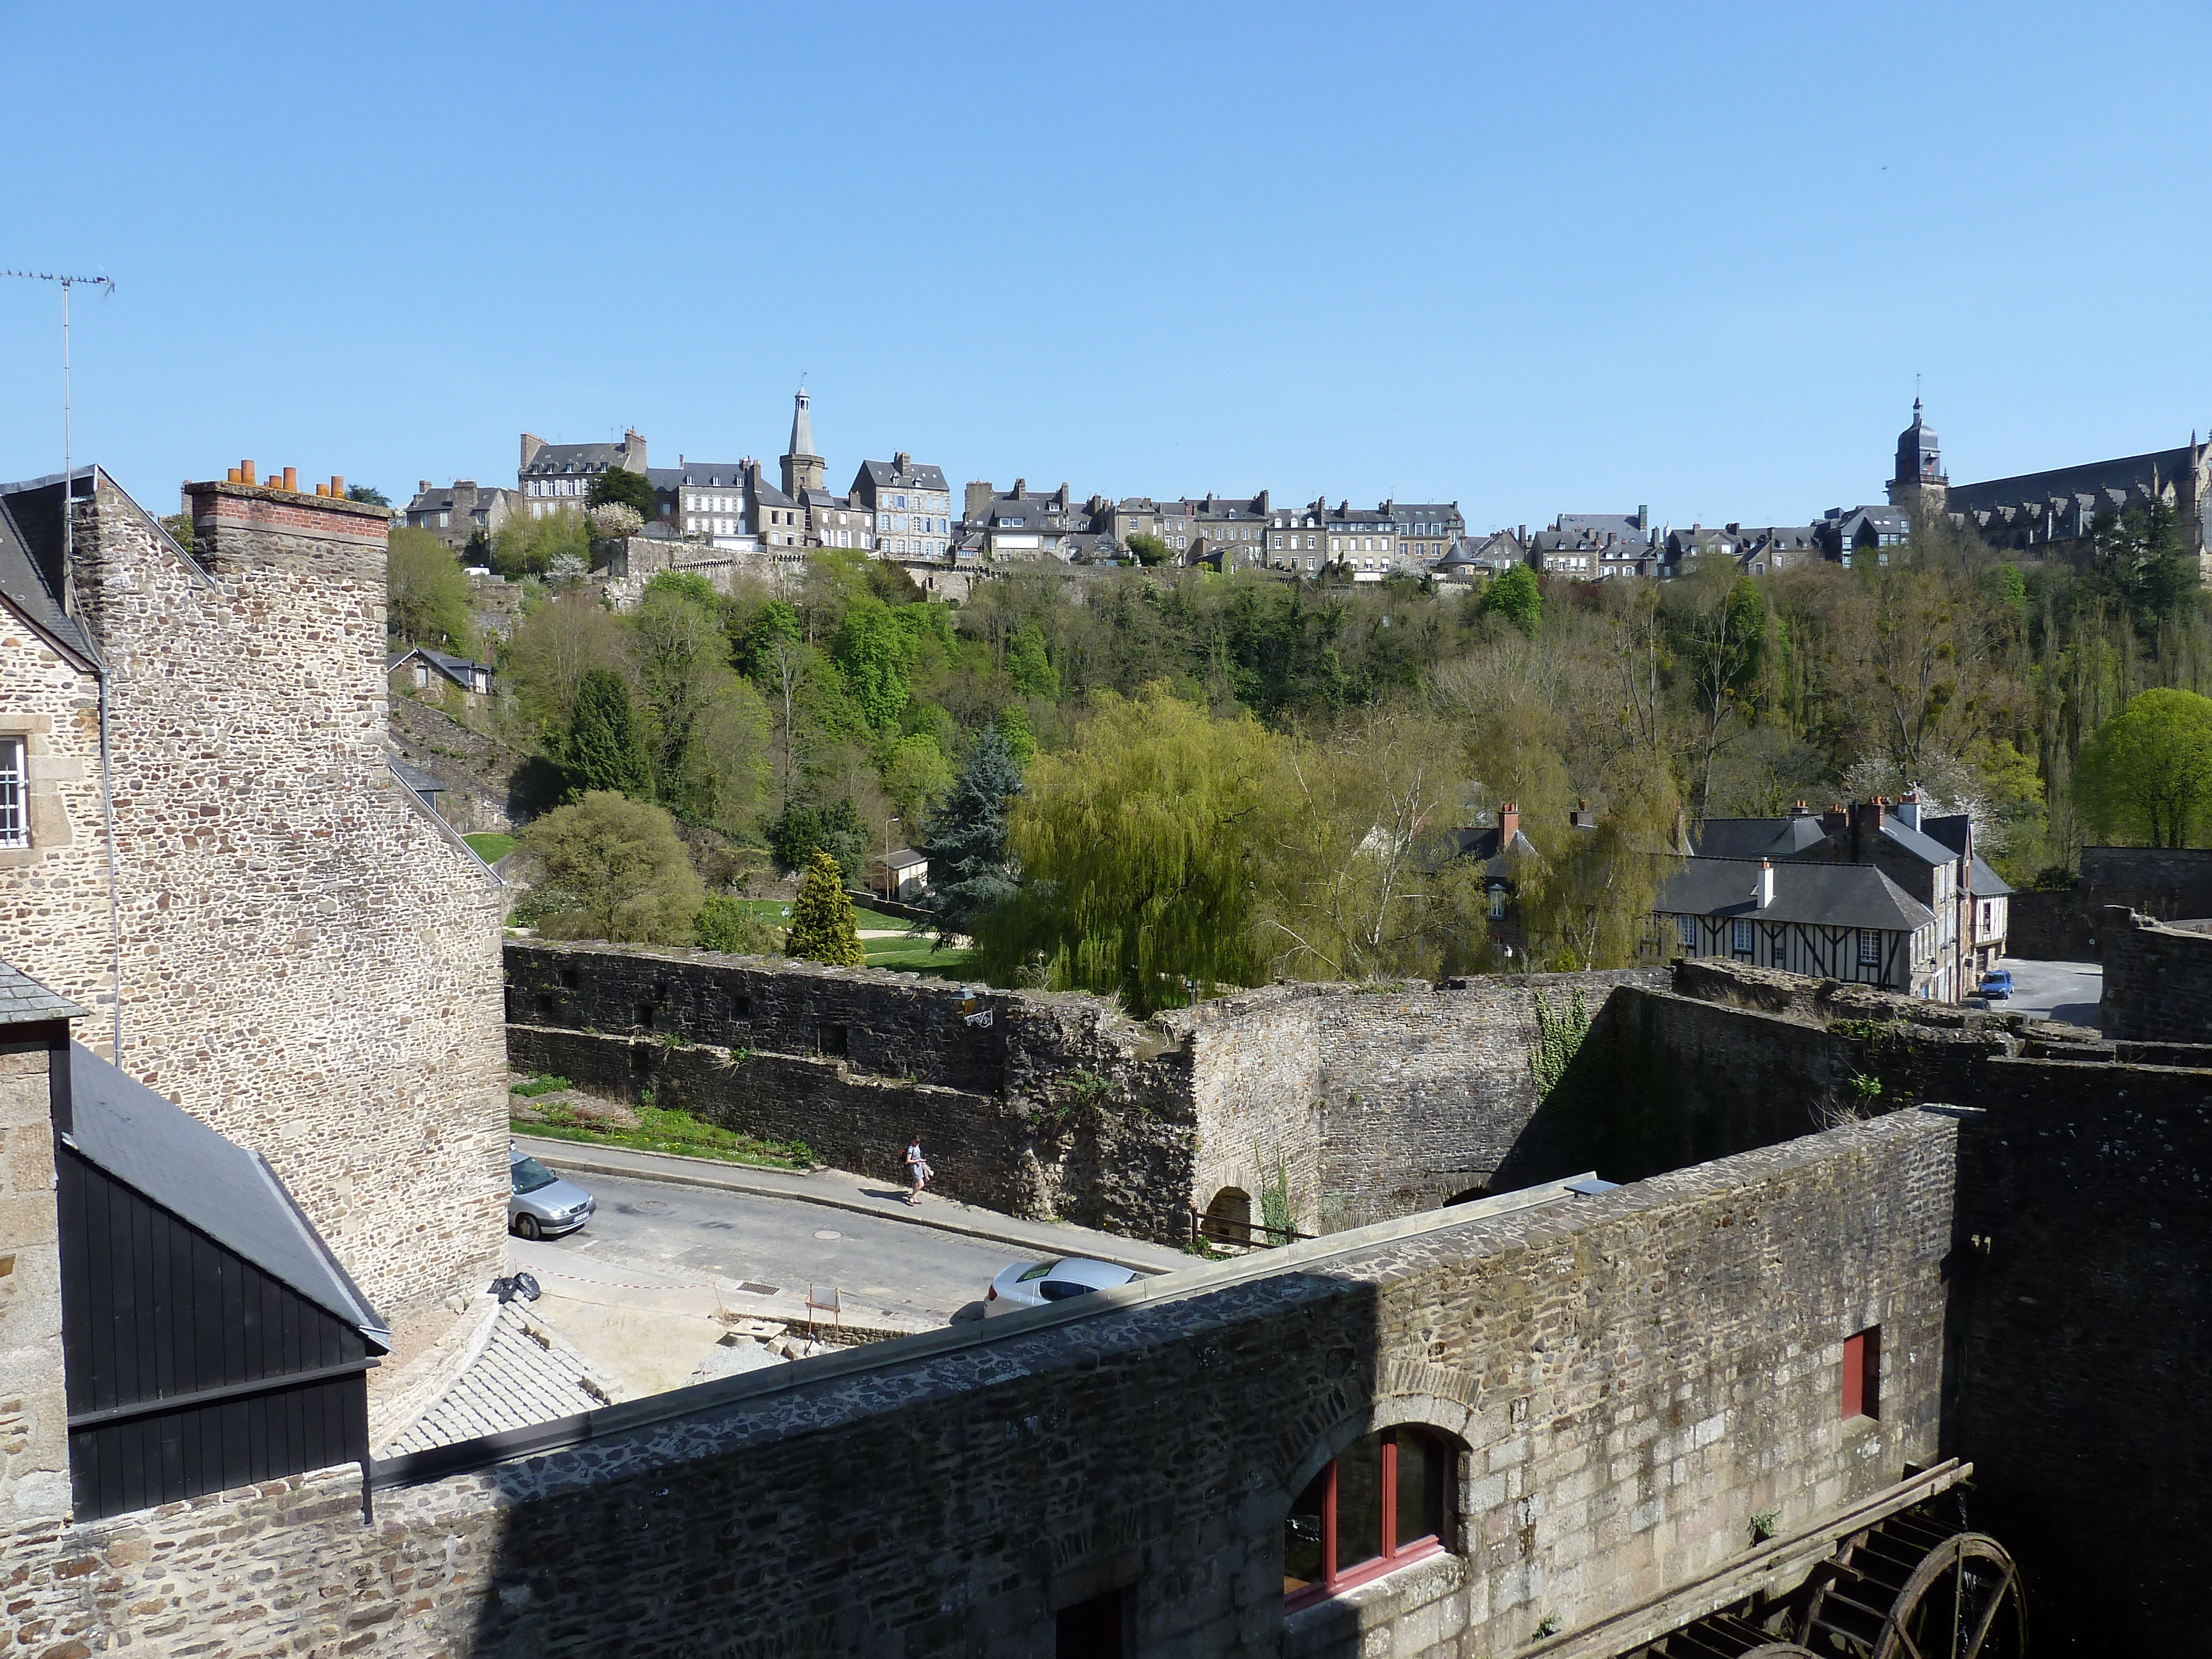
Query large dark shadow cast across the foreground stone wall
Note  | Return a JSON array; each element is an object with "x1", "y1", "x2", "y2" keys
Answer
[{"x1": 449, "y1": 1274, "x2": 1398, "y2": 1657}]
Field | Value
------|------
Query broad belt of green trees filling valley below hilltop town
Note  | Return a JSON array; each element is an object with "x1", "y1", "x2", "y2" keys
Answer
[{"x1": 392, "y1": 504, "x2": 2212, "y2": 1011}]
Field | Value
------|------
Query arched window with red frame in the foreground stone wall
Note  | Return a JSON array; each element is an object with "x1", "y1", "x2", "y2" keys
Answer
[{"x1": 1283, "y1": 1425, "x2": 1453, "y2": 1610}]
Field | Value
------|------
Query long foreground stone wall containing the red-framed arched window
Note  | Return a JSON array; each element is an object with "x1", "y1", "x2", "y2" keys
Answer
[{"x1": 0, "y1": 1113, "x2": 1958, "y2": 1659}]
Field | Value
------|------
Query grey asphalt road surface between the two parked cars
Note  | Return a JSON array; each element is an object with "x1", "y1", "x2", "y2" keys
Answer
[{"x1": 546, "y1": 1175, "x2": 1024, "y2": 1323}]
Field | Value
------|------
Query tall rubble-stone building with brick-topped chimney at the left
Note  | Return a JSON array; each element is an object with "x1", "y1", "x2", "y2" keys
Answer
[{"x1": 0, "y1": 469, "x2": 507, "y2": 1407}]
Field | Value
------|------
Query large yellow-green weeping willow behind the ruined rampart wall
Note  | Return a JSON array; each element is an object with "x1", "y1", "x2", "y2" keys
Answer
[{"x1": 978, "y1": 684, "x2": 1283, "y2": 1015}]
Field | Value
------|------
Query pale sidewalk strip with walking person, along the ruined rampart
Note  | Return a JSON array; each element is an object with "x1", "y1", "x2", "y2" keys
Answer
[{"x1": 513, "y1": 1130, "x2": 1197, "y2": 1272}]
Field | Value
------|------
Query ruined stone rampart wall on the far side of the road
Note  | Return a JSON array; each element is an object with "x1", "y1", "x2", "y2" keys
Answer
[{"x1": 507, "y1": 942, "x2": 1672, "y2": 1241}]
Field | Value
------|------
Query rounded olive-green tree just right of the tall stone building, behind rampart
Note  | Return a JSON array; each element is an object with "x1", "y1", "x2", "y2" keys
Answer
[{"x1": 520, "y1": 790, "x2": 706, "y2": 945}]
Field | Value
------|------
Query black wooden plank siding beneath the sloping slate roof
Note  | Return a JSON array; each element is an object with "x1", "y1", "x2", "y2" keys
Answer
[{"x1": 55, "y1": 1146, "x2": 369, "y2": 1520}]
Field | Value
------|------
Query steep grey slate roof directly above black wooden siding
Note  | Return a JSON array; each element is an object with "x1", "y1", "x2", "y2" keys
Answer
[{"x1": 66, "y1": 1042, "x2": 392, "y2": 1354}]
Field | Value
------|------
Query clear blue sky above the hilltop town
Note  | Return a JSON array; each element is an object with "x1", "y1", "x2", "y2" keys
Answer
[{"x1": 0, "y1": 0, "x2": 2212, "y2": 529}]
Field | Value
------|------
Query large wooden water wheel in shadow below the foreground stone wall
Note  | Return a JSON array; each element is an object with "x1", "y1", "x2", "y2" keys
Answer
[{"x1": 1798, "y1": 1513, "x2": 2028, "y2": 1659}]
